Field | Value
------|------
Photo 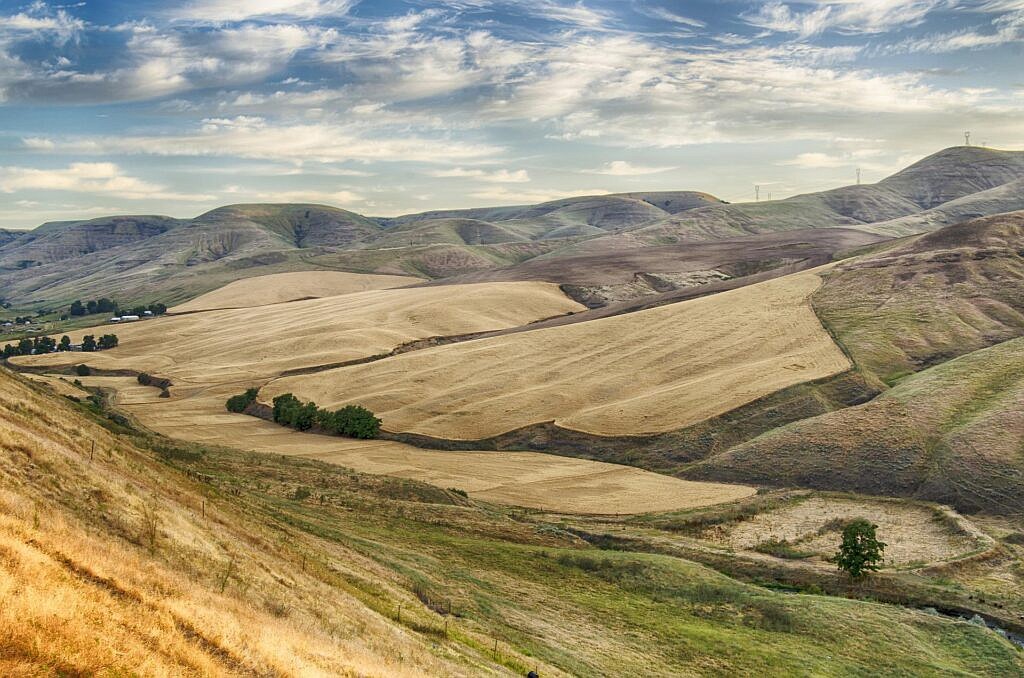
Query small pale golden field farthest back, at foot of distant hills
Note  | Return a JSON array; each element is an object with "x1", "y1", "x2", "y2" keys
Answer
[{"x1": 170, "y1": 270, "x2": 422, "y2": 313}]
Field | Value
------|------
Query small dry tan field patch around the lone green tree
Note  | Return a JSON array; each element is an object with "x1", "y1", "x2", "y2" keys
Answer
[{"x1": 710, "y1": 497, "x2": 991, "y2": 567}]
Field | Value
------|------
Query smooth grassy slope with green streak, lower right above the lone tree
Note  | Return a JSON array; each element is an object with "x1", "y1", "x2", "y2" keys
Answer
[{"x1": 687, "y1": 339, "x2": 1024, "y2": 513}]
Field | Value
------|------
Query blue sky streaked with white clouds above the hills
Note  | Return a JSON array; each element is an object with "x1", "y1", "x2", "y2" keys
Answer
[{"x1": 0, "y1": 0, "x2": 1024, "y2": 228}]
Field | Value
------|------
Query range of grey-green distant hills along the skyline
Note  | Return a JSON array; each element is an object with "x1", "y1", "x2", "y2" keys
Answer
[{"x1": 0, "y1": 146, "x2": 1024, "y2": 303}]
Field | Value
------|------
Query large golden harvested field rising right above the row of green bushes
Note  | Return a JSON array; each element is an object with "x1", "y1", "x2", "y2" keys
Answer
[{"x1": 268, "y1": 271, "x2": 850, "y2": 439}]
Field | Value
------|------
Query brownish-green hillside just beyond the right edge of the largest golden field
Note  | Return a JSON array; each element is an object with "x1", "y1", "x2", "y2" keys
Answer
[{"x1": 812, "y1": 212, "x2": 1024, "y2": 383}]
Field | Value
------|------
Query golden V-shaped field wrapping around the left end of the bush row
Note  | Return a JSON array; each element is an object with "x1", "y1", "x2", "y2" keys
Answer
[{"x1": 16, "y1": 283, "x2": 753, "y2": 513}]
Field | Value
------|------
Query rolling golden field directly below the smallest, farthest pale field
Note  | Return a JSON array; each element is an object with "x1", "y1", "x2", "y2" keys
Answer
[{"x1": 15, "y1": 283, "x2": 583, "y2": 392}]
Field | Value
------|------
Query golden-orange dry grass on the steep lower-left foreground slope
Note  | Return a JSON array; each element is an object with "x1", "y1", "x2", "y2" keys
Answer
[{"x1": 0, "y1": 372, "x2": 483, "y2": 676}]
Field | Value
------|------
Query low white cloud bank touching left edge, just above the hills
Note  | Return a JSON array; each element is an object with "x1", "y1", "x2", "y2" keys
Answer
[{"x1": 0, "y1": 163, "x2": 213, "y2": 202}]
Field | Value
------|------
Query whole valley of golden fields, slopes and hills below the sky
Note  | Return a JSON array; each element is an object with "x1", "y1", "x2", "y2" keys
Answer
[{"x1": 0, "y1": 147, "x2": 1024, "y2": 676}]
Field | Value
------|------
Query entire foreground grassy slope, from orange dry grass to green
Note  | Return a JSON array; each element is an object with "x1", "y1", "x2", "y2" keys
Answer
[{"x1": 0, "y1": 372, "x2": 1024, "y2": 675}]
